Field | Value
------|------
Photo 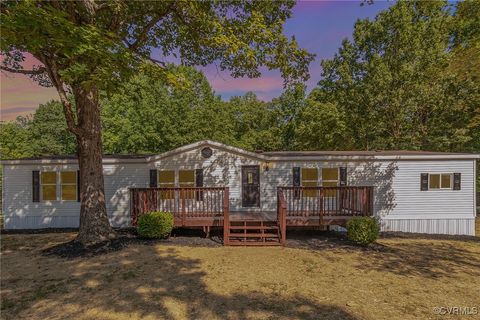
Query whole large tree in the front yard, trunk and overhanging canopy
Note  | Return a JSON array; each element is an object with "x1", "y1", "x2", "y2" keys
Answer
[{"x1": 0, "y1": 0, "x2": 312, "y2": 245}]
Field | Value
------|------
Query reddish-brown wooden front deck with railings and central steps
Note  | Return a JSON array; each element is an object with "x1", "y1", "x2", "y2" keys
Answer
[{"x1": 130, "y1": 186, "x2": 373, "y2": 245}]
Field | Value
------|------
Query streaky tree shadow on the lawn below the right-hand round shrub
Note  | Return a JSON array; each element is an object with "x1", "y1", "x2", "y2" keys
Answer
[{"x1": 287, "y1": 231, "x2": 480, "y2": 279}]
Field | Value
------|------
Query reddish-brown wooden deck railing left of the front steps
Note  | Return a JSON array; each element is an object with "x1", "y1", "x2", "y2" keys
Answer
[{"x1": 130, "y1": 187, "x2": 229, "y2": 226}]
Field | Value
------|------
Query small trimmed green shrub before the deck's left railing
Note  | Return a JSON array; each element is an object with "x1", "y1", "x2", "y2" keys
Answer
[{"x1": 137, "y1": 212, "x2": 173, "y2": 238}]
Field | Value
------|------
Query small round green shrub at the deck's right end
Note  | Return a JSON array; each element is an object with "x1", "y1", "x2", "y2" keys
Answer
[{"x1": 347, "y1": 217, "x2": 380, "y2": 246}]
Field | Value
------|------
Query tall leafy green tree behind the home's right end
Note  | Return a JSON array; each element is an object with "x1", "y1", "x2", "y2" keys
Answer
[{"x1": 314, "y1": 1, "x2": 480, "y2": 151}]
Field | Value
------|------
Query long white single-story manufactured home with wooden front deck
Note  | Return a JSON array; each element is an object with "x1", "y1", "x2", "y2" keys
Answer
[{"x1": 1, "y1": 141, "x2": 480, "y2": 243}]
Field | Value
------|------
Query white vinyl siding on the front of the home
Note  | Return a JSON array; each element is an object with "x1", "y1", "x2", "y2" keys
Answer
[{"x1": 3, "y1": 146, "x2": 475, "y2": 234}]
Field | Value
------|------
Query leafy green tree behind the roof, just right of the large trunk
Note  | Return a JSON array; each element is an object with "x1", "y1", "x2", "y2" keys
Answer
[{"x1": 101, "y1": 65, "x2": 231, "y2": 153}]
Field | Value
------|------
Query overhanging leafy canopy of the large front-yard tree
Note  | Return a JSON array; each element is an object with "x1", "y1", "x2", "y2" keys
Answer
[{"x1": 0, "y1": 0, "x2": 313, "y2": 91}]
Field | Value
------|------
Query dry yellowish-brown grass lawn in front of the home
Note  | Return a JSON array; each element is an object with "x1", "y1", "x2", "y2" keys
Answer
[{"x1": 1, "y1": 233, "x2": 480, "y2": 320}]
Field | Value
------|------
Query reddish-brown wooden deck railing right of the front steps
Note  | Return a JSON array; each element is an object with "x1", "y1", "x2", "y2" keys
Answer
[{"x1": 278, "y1": 186, "x2": 373, "y2": 220}]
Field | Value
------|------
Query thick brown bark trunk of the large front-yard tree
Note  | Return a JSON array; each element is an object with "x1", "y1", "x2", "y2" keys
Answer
[{"x1": 73, "y1": 86, "x2": 115, "y2": 245}]
